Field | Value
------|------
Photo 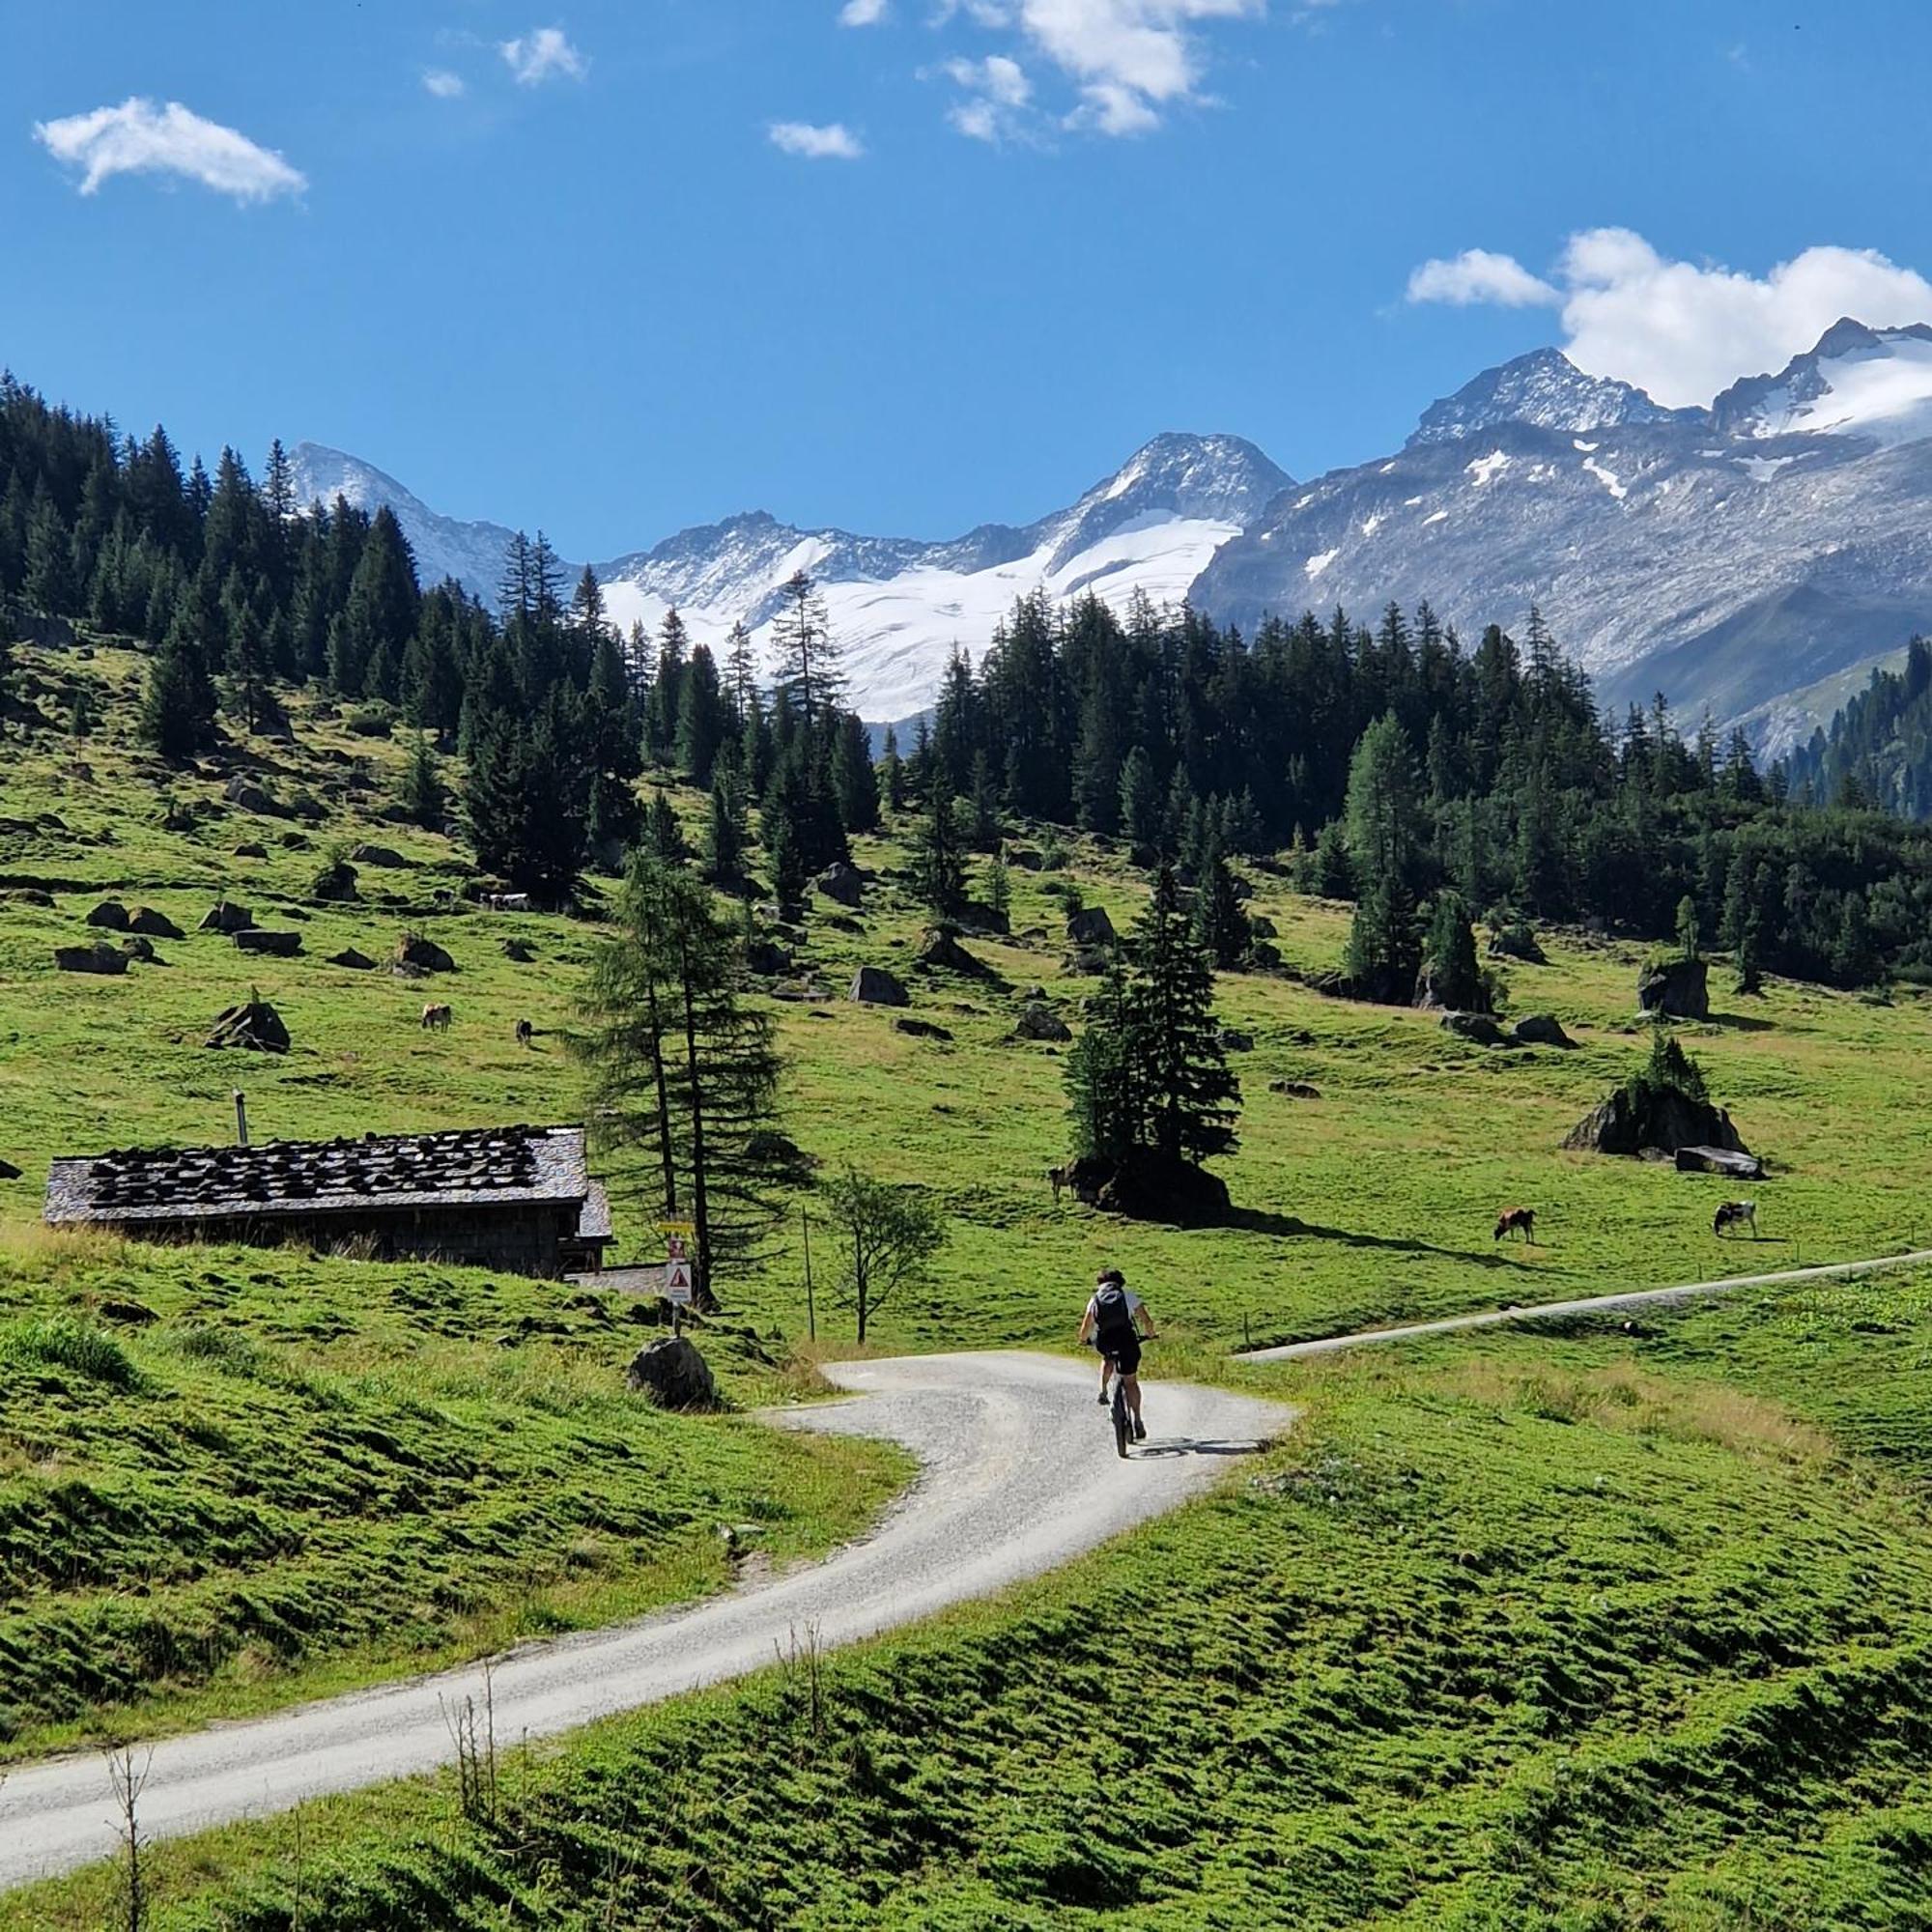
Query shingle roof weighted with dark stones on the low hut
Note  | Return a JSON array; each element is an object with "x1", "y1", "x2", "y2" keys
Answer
[{"x1": 46, "y1": 1126, "x2": 609, "y2": 1225}]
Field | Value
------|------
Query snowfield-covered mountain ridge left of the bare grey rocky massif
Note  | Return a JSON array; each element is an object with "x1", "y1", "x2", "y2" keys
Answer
[{"x1": 294, "y1": 435, "x2": 1291, "y2": 721}]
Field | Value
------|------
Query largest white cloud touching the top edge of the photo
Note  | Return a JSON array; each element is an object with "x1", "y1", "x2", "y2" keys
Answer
[{"x1": 939, "y1": 0, "x2": 1267, "y2": 135}]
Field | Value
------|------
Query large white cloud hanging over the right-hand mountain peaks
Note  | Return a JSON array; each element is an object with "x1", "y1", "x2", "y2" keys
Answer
[{"x1": 1408, "y1": 228, "x2": 1932, "y2": 406}]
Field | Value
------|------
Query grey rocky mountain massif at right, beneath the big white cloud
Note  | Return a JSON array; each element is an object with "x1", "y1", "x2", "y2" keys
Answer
[{"x1": 1192, "y1": 321, "x2": 1932, "y2": 750}]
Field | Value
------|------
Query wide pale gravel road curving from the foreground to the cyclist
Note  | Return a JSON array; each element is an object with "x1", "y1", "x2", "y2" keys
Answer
[{"x1": 0, "y1": 1354, "x2": 1293, "y2": 1886}]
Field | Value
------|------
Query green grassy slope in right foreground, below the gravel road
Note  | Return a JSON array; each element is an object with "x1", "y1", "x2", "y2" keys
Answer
[{"x1": 18, "y1": 1279, "x2": 1932, "y2": 1932}]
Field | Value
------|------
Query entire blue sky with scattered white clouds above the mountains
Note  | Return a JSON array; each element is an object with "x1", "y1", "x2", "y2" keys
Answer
[{"x1": 0, "y1": 0, "x2": 1932, "y2": 556}]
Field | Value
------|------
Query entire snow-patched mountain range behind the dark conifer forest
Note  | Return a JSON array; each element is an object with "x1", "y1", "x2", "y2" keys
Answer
[{"x1": 296, "y1": 321, "x2": 1932, "y2": 750}]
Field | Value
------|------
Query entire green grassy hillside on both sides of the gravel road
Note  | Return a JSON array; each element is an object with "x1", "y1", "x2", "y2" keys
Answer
[{"x1": 0, "y1": 630, "x2": 1932, "y2": 1932}]
